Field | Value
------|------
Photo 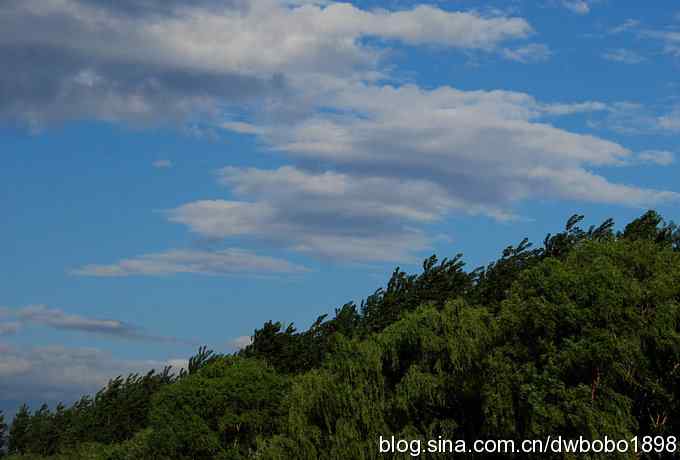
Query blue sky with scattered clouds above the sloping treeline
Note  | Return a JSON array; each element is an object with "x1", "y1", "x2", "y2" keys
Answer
[{"x1": 0, "y1": 0, "x2": 680, "y2": 416}]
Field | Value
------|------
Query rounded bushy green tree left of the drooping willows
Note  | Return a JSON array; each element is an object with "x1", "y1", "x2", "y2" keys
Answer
[{"x1": 149, "y1": 357, "x2": 288, "y2": 460}]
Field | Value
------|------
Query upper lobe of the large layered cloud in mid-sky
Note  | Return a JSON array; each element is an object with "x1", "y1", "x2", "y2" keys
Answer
[{"x1": 267, "y1": 84, "x2": 630, "y2": 169}]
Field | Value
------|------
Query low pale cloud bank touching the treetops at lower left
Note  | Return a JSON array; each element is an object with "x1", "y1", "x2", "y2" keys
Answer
[{"x1": 0, "y1": 346, "x2": 185, "y2": 416}]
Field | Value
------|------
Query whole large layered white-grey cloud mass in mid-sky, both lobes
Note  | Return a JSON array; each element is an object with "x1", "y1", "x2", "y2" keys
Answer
[{"x1": 159, "y1": 82, "x2": 679, "y2": 262}]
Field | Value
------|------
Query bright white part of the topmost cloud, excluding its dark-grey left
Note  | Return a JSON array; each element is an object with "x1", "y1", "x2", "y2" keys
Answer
[{"x1": 142, "y1": 0, "x2": 531, "y2": 74}]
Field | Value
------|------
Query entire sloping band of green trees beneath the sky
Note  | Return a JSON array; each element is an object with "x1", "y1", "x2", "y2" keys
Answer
[{"x1": 0, "y1": 211, "x2": 680, "y2": 460}]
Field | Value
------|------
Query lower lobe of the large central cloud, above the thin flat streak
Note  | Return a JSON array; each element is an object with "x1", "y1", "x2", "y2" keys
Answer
[{"x1": 169, "y1": 167, "x2": 440, "y2": 261}]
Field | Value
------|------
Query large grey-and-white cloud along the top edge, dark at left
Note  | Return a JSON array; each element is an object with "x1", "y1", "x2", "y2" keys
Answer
[{"x1": 0, "y1": 0, "x2": 532, "y2": 129}]
